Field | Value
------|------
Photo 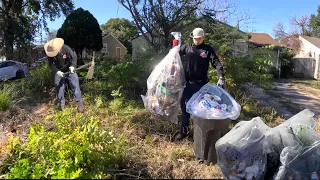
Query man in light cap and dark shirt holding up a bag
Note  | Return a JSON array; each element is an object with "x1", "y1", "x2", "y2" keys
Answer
[{"x1": 173, "y1": 28, "x2": 225, "y2": 141}]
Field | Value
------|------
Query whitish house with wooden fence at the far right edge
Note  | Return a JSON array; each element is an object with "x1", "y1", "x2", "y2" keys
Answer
[{"x1": 294, "y1": 36, "x2": 320, "y2": 79}]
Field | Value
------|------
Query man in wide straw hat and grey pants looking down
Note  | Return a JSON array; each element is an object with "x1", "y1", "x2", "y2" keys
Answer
[{"x1": 44, "y1": 38, "x2": 84, "y2": 113}]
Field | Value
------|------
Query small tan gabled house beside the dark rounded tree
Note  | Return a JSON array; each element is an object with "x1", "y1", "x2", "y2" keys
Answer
[{"x1": 101, "y1": 34, "x2": 127, "y2": 61}]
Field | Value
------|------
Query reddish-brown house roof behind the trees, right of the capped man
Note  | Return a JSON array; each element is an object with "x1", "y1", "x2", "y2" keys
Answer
[{"x1": 248, "y1": 32, "x2": 281, "y2": 46}]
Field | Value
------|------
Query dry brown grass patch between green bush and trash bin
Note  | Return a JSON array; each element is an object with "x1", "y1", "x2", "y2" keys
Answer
[{"x1": 103, "y1": 110, "x2": 222, "y2": 179}]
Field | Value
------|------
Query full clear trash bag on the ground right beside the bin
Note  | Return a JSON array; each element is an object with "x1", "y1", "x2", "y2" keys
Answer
[{"x1": 215, "y1": 117, "x2": 270, "y2": 180}]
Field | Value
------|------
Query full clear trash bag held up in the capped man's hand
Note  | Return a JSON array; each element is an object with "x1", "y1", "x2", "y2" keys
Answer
[{"x1": 141, "y1": 32, "x2": 186, "y2": 124}]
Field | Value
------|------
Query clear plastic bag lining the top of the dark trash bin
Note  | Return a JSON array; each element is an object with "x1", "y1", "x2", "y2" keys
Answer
[{"x1": 187, "y1": 84, "x2": 241, "y2": 120}]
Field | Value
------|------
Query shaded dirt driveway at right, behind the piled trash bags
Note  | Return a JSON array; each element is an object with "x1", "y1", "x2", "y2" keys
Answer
[{"x1": 244, "y1": 81, "x2": 320, "y2": 133}]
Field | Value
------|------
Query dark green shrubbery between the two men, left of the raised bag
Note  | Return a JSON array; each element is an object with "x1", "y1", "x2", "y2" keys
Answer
[{"x1": 84, "y1": 54, "x2": 163, "y2": 99}]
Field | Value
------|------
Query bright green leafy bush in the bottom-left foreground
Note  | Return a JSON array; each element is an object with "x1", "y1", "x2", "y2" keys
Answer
[{"x1": 0, "y1": 107, "x2": 124, "y2": 179}]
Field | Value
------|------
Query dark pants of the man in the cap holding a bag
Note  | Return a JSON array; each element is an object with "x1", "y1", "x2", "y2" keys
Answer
[{"x1": 180, "y1": 82, "x2": 204, "y2": 133}]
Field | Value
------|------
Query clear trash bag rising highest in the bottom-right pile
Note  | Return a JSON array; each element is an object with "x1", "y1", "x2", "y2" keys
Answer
[{"x1": 266, "y1": 109, "x2": 320, "y2": 179}]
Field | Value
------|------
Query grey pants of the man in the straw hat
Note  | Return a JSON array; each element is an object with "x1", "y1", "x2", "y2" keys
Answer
[{"x1": 54, "y1": 73, "x2": 83, "y2": 106}]
